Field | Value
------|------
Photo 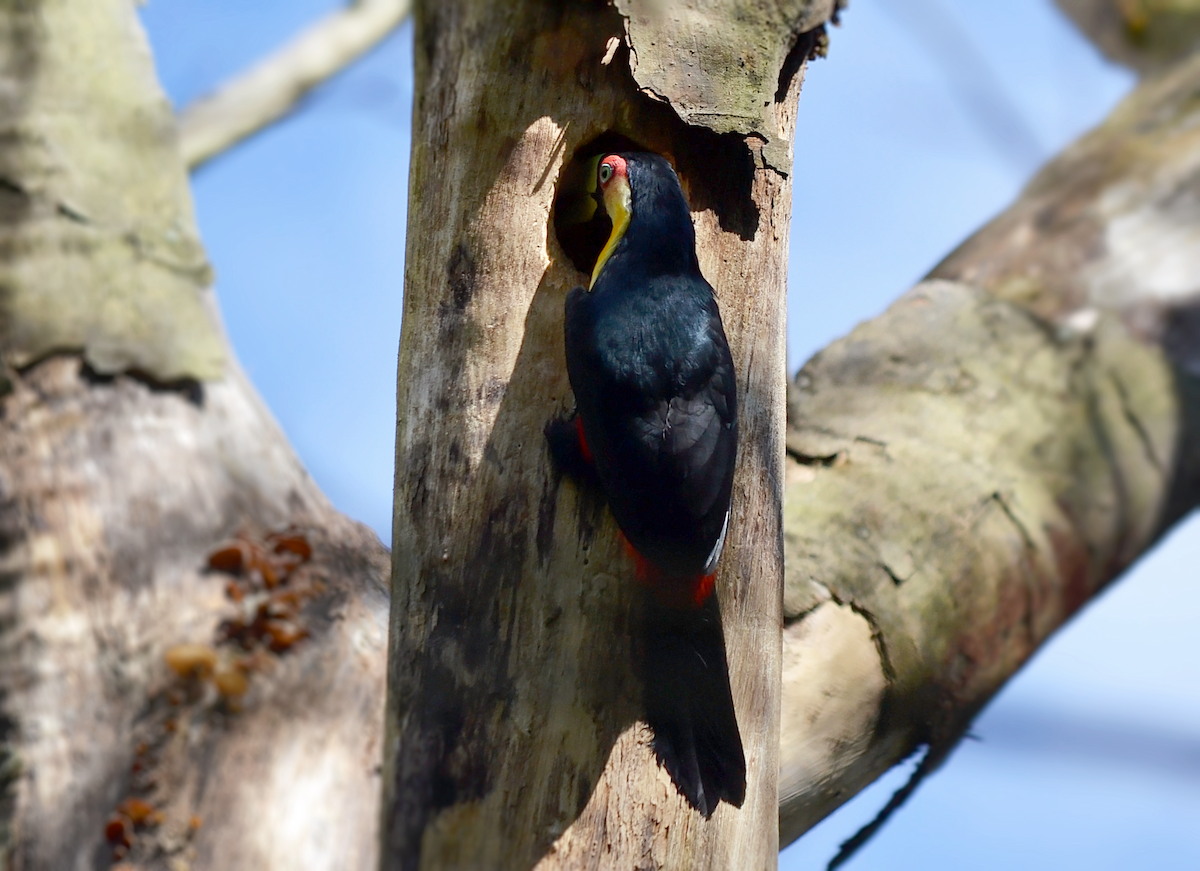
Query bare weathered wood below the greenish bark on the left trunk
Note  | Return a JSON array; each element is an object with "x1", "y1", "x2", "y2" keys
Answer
[{"x1": 0, "y1": 356, "x2": 386, "y2": 869}]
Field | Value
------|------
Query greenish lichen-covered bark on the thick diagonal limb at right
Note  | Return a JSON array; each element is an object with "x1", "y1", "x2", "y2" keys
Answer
[{"x1": 780, "y1": 282, "x2": 1186, "y2": 843}]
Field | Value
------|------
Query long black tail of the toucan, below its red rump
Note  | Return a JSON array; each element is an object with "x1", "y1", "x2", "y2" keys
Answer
[{"x1": 641, "y1": 589, "x2": 746, "y2": 817}]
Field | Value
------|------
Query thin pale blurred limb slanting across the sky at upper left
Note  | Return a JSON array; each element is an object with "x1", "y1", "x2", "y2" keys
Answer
[{"x1": 179, "y1": 0, "x2": 413, "y2": 169}]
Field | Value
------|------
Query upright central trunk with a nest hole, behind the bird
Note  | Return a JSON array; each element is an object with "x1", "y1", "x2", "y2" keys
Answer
[{"x1": 384, "y1": 0, "x2": 832, "y2": 869}]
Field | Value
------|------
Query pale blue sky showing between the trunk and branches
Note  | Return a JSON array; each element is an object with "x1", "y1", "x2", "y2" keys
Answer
[{"x1": 143, "y1": 0, "x2": 1200, "y2": 871}]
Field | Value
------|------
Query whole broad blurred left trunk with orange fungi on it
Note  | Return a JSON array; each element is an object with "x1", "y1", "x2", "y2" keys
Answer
[{"x1": 0, "y1": 0, "x2": 386, "y2": 871}]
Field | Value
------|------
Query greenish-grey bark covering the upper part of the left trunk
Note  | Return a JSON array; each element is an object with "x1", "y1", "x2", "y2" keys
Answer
[{"x1": 0, "y1": 0, "x2": 226, "y2": 382}]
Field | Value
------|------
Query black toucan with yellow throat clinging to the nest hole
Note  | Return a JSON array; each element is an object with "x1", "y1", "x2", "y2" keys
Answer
[{"x1": 546, "y1": 152, "x2": 745, "y2": 817}]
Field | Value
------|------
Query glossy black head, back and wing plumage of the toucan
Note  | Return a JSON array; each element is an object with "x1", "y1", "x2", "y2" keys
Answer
[{"x1": 565, "y1": 155, "x2": 737, "y2": 577}]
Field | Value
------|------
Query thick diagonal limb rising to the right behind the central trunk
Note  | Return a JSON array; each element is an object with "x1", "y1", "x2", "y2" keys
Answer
[{"x1": 780, "y1": 17, "x2": 1200, "y2": 843}]
